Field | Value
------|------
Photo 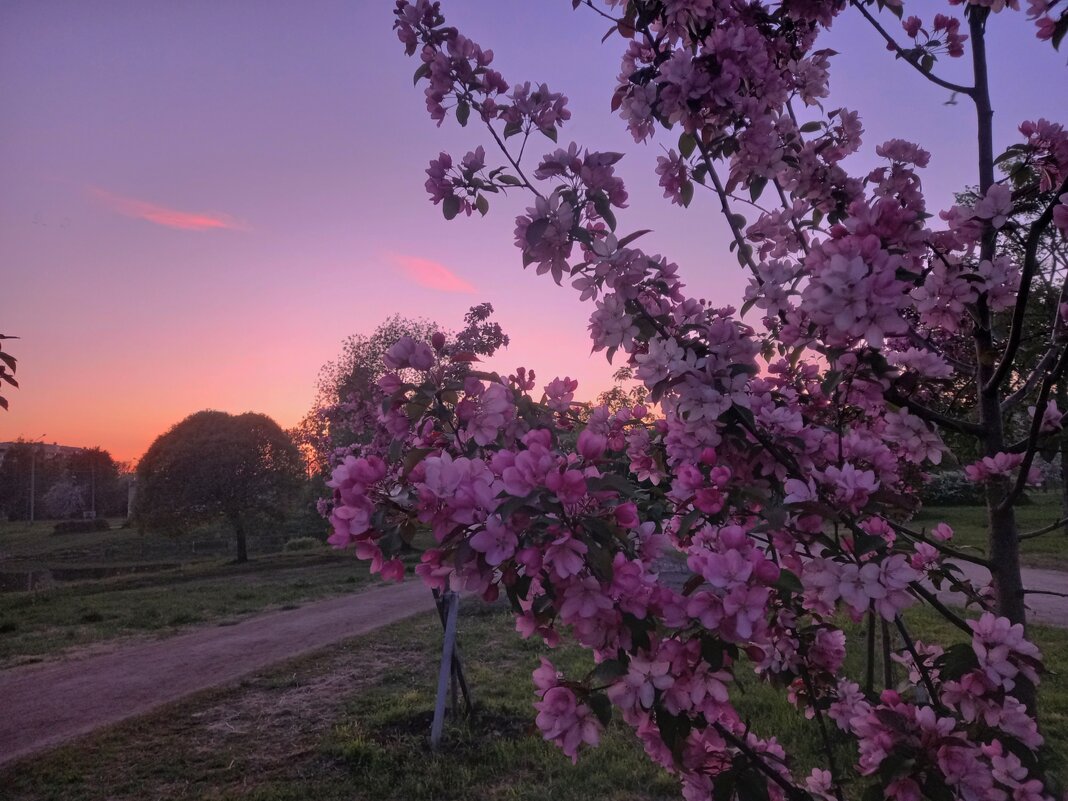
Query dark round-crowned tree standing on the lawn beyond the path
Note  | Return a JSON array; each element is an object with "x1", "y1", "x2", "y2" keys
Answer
[{"x1": 135, "y1": 411, "x2": 303, "y2": 562}]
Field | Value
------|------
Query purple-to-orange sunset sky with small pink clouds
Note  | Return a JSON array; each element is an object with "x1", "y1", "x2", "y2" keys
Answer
[{"x1": 0, "y1": 0, "x2": 1068, "y2": 460}]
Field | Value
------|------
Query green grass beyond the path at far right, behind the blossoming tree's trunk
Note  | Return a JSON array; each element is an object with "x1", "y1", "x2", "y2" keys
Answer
[{"x1": 911, "y1": 492, "x2": 1068, "y2": 571}]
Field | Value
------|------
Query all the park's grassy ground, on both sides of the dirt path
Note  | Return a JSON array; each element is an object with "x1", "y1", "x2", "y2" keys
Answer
[{"x1": 0, "y1": 498, "x2": 1068, "y2": 801}]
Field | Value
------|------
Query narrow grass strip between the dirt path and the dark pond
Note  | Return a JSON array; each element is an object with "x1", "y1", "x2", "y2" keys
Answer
[{"x1": 0, "y1": 547, "x2": 371, "y2": 666}]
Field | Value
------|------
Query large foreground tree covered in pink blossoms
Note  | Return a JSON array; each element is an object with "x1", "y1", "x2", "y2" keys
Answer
[{"x1": 320, "y1": 0, "x2": 1068, "y2": 801}]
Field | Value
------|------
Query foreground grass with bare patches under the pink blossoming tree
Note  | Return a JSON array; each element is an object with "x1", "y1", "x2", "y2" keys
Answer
[{"x1": 0, "y1": 600, "x2": 1068, "y2": 801}]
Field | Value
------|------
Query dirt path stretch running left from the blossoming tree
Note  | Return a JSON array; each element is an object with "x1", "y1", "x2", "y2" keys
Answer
[{"x1": 0, "y1": 580, "x2": 434, "y2": 765}]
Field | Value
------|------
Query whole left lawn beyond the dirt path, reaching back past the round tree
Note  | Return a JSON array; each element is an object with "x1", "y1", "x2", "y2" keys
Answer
[{"x1": 0, "y1": 520, "x2": 399, "y2": 668}]
